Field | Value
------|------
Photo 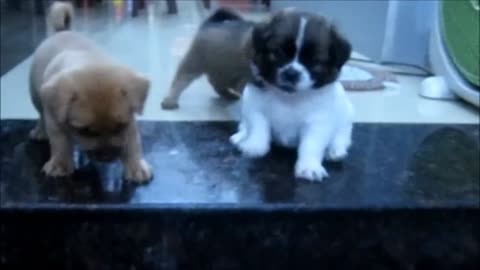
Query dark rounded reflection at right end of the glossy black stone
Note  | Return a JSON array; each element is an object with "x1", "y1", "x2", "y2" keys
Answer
[{"x1": 407, "y1": 128, "x2": 480, "y2": 203}]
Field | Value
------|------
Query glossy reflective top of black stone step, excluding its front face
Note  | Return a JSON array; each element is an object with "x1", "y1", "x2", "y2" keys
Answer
[{"x1": 0, "y1": 120, "x2": 480, "y2": 208}]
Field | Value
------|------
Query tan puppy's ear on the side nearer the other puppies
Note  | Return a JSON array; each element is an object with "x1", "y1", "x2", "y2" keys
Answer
[{"x1": 123, "y1": 74, "x2": 150, "y2": 114}]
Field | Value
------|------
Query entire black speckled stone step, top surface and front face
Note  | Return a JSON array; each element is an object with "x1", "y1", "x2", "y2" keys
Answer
[{"x1": 0, "y1": 120, "x2": 480, "y2": 269}]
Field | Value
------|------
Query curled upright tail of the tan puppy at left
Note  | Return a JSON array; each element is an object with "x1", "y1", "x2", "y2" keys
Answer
[{"x1": 47, "y1": 1, "x2": 74, "y2": 34}]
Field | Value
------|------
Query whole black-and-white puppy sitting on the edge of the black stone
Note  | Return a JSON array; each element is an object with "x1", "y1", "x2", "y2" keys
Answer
[{"x1": 230, "y1": 9, "x2": 354, "y2": 181}]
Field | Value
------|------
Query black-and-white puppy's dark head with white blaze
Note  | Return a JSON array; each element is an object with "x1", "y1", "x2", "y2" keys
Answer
[{"x1": 251, "y1": 10, "x2": 352, "y2": 92}]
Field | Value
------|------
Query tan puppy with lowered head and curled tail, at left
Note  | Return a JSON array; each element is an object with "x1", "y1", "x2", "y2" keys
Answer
[{"x1": 30, "y1": 3, "x2": 152, "y2": 182}]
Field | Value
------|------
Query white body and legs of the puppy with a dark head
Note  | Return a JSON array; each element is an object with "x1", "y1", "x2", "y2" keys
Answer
[{"x1": 230, "y1": 82, "x2": 354, "y2": 181}]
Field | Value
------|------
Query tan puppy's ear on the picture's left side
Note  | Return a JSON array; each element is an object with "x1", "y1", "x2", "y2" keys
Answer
[{"x1": 40, "y1": 76, "x2": 75, "y2": 123}]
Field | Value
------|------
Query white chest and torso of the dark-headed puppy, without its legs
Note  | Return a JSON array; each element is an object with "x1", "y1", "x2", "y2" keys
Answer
[{"x1": 242, "y1": 82, "x2": 353, "y2": 148}]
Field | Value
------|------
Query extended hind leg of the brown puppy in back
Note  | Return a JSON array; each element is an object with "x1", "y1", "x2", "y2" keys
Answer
[{"x1": 162, "y1": 53, "x2": 202, "y2": 110}]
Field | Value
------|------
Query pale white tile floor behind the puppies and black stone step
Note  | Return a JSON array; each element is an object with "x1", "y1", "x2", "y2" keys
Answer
[{"x1": 1, "y1": 1, "x2": 480, "y2": 124}]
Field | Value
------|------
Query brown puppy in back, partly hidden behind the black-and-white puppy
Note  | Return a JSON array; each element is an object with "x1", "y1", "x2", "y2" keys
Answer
[{"x1": 162, "y1": 9, "x2": 253, "y2": 109}]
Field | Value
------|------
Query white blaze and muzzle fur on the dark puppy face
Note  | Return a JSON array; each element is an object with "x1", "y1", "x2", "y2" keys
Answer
[{"x1": 277, "y1": 18, "x2": 314, "y2": 91}]
